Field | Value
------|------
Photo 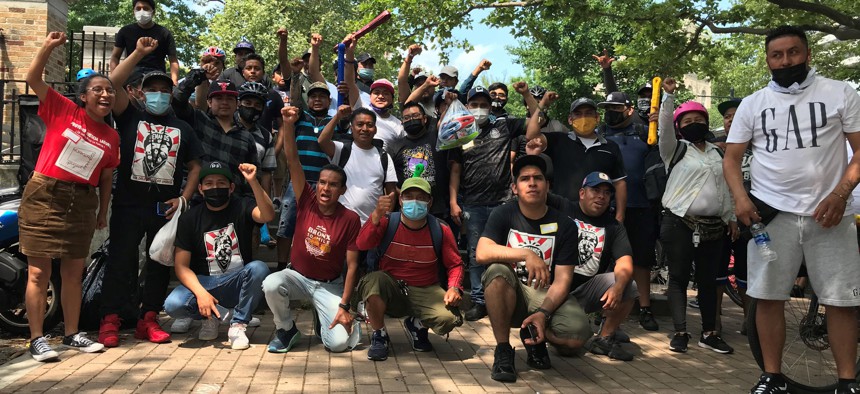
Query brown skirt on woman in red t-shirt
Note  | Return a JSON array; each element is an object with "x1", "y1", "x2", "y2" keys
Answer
[{"x1": 18, "y1": 172, "x2": 99, "y2": 259}]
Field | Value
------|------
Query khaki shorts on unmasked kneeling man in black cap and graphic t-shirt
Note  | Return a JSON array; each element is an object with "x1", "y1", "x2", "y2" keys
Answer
[{"x1": 481, "y1": 263, "x2": 594, "y2": 341}]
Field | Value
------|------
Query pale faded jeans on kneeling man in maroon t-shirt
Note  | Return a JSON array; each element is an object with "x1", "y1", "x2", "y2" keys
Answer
[{"x1": 263, "y1": 268, "x2": 361, "y2": 353}]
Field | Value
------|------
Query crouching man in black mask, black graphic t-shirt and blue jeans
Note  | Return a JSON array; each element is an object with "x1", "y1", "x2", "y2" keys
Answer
[{"x1": 164, "y1": 162, "x2": 275, "y2": 349}]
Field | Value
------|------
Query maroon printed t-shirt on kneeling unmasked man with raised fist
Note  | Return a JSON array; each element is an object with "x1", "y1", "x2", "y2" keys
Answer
[{"x1": 290, "y1": 182, "x2": 361, "y2": 280}]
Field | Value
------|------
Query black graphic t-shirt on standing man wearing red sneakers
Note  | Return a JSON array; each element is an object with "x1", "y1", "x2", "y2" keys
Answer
[{"x1": 114, "y1": 105, "x2": 203, "y2": 205}]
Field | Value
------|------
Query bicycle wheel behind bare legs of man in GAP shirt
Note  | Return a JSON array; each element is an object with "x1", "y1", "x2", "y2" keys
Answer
[{"x1": 747, "y1": 298, "x2": 856, "y2": 393}]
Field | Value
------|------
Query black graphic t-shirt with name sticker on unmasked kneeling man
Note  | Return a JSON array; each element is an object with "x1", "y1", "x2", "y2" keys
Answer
[{"x1": 481, "y1": 200, "x2": 579, "y2": 284}]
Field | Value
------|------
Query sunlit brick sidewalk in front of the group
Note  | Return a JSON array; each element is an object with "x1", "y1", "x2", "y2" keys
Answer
[{"x1": 0, "y1": 298, "x2": 760, "y2": 394}]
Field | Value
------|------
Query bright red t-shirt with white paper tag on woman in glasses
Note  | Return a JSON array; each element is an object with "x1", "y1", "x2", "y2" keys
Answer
[{"x1": 36, "y1": 89, "x2": 119, "y2": 186}]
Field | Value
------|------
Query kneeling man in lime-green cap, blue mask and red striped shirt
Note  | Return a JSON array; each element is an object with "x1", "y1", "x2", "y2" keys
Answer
[{"x1": 356, "y1": 177, "x2": 463, "y2": 361}]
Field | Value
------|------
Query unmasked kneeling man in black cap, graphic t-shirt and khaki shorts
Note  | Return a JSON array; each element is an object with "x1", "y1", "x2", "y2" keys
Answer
[{"x1": 476, "y1": 155, "x2": 592, "y2": 382}]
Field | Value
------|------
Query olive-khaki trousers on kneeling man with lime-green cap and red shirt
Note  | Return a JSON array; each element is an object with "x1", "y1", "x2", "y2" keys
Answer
[{"x1": 358, "y1": 271, "x2": 463, "y2": 335}]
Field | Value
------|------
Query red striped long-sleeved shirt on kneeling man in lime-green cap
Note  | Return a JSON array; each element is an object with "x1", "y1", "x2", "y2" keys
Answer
[{"x1": 356, "y1": 217, "x2": 463, "y2": 288}]
